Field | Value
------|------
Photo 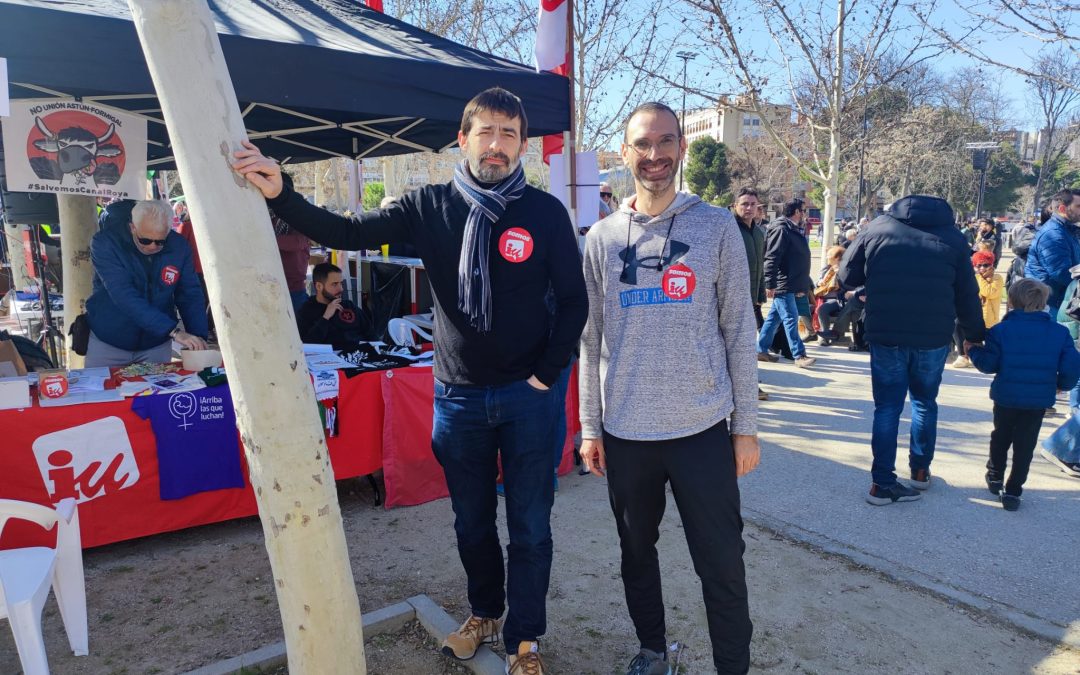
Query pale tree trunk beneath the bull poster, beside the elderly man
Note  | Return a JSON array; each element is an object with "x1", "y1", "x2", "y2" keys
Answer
[{"x1": 56, "y1": 194, "x2": 97, "y2": 368}]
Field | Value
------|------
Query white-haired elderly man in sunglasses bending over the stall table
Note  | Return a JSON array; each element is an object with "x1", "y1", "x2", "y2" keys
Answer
[{"x1": 86, "y1": 201, "x2": 208, "y2": 367}]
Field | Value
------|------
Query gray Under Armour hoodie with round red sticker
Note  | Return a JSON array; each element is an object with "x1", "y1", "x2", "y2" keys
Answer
[{"x1": 580, "y1": 192, "x2": 757, "y2": 441}]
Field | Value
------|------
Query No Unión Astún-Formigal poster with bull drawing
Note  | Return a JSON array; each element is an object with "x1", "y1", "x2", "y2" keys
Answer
[{"x1": 3, "y1": 99, "x2": 146, "y2": 199}]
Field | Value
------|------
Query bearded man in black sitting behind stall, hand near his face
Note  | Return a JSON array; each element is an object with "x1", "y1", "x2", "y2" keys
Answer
[{"x1": 296, "y1": 262, "x2": 372, "y2": 349}]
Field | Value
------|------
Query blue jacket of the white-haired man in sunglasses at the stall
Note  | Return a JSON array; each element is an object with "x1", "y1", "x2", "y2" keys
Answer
[{"x1": 86, "y1": 227, "x2": 210, "y2": 351}]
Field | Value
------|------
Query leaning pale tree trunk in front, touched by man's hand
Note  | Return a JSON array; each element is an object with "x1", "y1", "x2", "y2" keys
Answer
[{"x1": 129, "y1": 0, "x2": 366, "y2": 675}]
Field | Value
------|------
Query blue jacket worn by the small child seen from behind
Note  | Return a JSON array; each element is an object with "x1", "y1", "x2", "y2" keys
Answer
[{"x1": 968, "y1": 310, "x2": 1080, "y2": 410}]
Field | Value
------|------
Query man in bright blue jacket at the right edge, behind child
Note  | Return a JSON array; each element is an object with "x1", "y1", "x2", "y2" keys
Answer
[{"x1": 1024, "y1": 188, "x2": 1080, "y2": 316}]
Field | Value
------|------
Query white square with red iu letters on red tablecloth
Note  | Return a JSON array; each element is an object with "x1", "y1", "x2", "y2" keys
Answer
[{"x1": 33, "y1": 417, "x2": 139, "y2": 503}]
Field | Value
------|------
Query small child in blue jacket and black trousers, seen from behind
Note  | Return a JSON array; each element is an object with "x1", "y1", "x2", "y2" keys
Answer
[{"x1": 968, "y1": 279, "x2": 1080, "y2": 511}]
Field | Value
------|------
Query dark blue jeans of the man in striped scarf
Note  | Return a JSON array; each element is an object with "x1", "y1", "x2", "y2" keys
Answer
[{"x1": 431, "y1": 380, "x2": 565, "y2": 653}]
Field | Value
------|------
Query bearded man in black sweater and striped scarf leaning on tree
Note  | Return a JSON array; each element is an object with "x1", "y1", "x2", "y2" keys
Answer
[{"x1": 233, "y1": 89, "x2": 589, "y2": 673}]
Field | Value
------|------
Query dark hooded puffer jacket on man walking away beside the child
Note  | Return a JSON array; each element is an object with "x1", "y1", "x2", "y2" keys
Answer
[{"x1": 839, "y1": 195, "x2": 986, "y2": 349}]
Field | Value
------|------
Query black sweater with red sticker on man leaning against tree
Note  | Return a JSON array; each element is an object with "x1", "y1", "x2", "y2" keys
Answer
[{"x1": 268, "y1": 184, "x2": 589, "y2": 386}]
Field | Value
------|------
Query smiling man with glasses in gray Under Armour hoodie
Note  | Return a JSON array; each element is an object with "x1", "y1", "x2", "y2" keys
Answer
[{"x1": 580, "y1": 103, "x2": 760, "y2": 675}]
